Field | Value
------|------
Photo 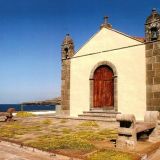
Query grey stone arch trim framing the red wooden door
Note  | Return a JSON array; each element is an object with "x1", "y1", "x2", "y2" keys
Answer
[{"x1": 89, "y1": 61, "x2": 118, "y2": 111}]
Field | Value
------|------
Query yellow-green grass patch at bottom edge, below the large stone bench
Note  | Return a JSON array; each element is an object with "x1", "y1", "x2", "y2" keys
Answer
[{"x1": 87, "y1": 150, "x2": 133, "y2": 160}]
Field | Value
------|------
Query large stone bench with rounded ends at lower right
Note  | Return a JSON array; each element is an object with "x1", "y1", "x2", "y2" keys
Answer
[{"x1": 116, "y1": 111, "x2": 159, "y2": 147}]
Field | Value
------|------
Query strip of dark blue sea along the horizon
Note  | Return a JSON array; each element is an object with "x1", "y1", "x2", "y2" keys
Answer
[{"x1": 0, "y1": 104, "x2": 55, "y2": 112}]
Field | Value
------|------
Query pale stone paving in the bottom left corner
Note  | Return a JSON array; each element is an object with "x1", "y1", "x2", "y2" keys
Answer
[{"x1": 0, "y1": 141, "x2": 79, "y2": 160}]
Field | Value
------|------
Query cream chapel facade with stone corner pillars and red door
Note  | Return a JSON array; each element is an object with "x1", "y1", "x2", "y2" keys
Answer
[{"x1": 61, "y1": 9, "x2": 160, "y2": 120}]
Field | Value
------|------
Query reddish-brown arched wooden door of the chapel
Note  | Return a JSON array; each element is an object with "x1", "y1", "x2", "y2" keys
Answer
[{"x1": 93, "y1": 65, "x2": 114, "y2": 109}]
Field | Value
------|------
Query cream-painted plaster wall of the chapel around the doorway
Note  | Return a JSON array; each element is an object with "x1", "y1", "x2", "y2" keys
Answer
[{"x1": 70, "y1": 28, "x2": 146, "y2": 120}]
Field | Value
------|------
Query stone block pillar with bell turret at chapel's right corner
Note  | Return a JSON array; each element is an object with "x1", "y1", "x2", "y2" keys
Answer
[{"x1": 145, "y1": 9, "x2": 160, "y2": 111}]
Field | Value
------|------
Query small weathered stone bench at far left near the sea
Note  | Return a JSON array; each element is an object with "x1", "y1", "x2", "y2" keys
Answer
[{"x1": 0, "y1": 108, "x2": 16, "y2": 122}]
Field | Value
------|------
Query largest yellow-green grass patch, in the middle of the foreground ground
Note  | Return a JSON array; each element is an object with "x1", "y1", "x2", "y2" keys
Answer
[{"x1": 27, "y1": 128, "x2": 113, "y2": 152}]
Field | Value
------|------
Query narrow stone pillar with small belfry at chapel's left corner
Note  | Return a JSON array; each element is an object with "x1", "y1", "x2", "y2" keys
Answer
[{"x1": 61, "y1": 34, "x2": 74, "y2": 115}]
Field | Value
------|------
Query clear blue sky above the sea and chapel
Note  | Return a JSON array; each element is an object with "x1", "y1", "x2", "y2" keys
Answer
[{"x1": 0, "y1": 0, "x2": 160, "y2": 104}]
